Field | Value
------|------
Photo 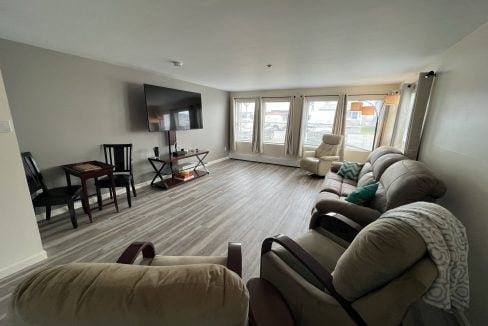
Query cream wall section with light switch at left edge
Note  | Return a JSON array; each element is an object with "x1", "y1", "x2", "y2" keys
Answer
[{"x1": 0, "y1": 72, "x2": 47, "y2": 278}]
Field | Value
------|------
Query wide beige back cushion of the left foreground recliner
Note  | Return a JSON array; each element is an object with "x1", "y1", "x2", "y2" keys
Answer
[{"x1": 9, "y1": 263, "x2": 249, "y2": 326}]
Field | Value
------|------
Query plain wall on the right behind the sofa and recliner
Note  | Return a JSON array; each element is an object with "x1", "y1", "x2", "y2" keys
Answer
[{"x1": 419, "y1": 24, "x2": 488, "y2": 325}]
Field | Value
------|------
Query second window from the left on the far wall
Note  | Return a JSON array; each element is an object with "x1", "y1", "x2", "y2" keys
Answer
[{"x1": 263, "y1": 98, "x2": 290, "y2": 145}]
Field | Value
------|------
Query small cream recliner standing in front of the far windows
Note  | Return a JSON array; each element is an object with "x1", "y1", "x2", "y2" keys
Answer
[{"x1": 300, "y1": 134, "x2": 343, "y2": 177}]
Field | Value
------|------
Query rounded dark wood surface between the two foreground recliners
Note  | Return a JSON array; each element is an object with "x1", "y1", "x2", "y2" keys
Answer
[{"x1": 247, "y1": 278, "x2": 295, "y2": 326}]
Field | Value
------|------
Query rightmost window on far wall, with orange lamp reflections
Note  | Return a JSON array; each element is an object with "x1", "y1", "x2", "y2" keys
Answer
[{"x1": 345, "y1": 97, "x2": 383, "y2": 151}]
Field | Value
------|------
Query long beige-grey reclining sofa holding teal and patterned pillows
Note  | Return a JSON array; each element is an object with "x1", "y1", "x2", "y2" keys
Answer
[{"x1": 310, "y1": 146, "x2": 446, "y2": 241}]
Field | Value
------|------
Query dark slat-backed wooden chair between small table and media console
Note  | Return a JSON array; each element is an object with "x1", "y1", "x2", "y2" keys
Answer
[{"x1": 95, "y1": 144, "x2": 137, "y2": 207}]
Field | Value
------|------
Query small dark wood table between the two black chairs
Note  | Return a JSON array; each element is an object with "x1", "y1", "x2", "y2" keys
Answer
[{"x1": 62, "y1": 161, "x2": 119, "y2": 223}]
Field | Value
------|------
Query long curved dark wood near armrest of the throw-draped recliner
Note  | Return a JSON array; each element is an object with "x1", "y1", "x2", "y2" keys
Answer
[{"x1": 261, "y1": 234, "x2": 366, "y2": 326}]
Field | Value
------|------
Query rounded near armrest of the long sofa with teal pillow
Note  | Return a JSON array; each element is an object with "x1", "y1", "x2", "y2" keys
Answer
[{"x1": 315, "y1": 199, "x2": 381, "y2": 226}]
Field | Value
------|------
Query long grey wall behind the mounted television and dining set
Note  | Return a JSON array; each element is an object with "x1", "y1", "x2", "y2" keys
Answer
[{"x1": 0, "y1": 39, "x2": 229, "y2": 191}]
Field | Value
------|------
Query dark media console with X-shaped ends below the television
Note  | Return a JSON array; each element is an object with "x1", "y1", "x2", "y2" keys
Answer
[{"x1": 148, "y1": 150, "x2": 209, "y2": 189}]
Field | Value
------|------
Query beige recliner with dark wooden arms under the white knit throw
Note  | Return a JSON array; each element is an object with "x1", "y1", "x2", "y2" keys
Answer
[{"x1": 248, "y1": 202, "x2": 438, "y2": 326}]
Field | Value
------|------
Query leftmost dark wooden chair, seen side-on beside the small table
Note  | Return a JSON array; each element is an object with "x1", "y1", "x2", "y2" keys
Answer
[{"x1": 22, "y1": 152, "x2": 81, "y2": 229}]
